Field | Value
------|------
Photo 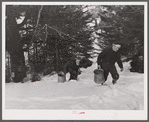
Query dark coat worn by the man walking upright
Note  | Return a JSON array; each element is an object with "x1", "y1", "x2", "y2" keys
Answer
[{"x1": 97, "y1": 47, "x2": 123, "y2": 70}]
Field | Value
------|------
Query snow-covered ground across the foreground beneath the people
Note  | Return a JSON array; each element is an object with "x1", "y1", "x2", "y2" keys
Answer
[{"x1": 5, "y1": 59, "x2": 147, "y2": 119}]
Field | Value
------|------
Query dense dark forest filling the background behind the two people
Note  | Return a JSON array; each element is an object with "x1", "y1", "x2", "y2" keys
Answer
[{"x1": 5, "y1": 5, "x2": 144, "y2": 82}]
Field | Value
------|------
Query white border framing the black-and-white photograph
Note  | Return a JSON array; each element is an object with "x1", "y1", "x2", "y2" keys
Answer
[{"x1": 2, "y1": 2, "x2": 148, "y2": 120}]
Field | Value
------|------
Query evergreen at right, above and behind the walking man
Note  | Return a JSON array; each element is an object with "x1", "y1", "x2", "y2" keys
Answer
[{"x1": 93, "y1": 5, "x2": 144, "y2": 72}]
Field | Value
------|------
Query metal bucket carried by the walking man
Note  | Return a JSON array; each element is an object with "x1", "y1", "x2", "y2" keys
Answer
[{"x1": 94, "y1": 69, "x2": 105, "y2": 84}]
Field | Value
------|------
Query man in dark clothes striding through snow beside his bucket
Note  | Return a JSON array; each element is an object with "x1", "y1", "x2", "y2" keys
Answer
[{"x1": 97, "y1": 43, "x2": 123, "y2": 85}]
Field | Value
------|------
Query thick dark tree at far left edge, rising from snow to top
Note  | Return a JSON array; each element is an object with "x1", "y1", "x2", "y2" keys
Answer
[{"x1": 6, "y1": 5, "x2": 31, "y2": 82}]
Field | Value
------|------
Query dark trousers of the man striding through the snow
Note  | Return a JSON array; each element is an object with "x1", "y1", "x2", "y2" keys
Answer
[{"x1": 101, "y1": 63, "x2": 119, "y2": 81}]
